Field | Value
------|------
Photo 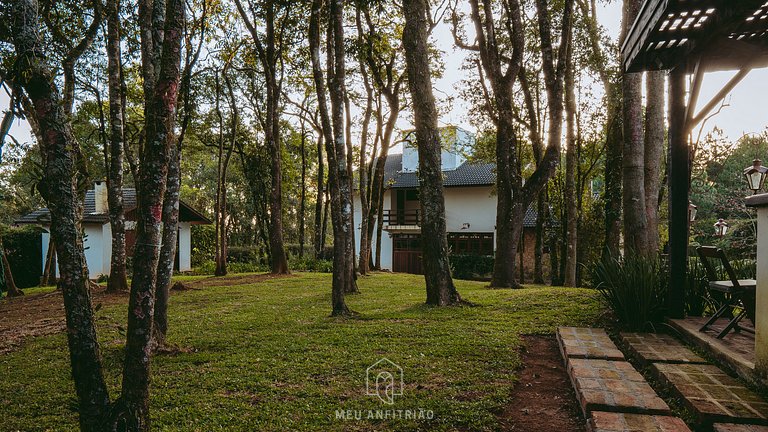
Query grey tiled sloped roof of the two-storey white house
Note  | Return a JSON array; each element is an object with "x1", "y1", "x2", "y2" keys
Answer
[{"x1": 384, "y1": 154, "x2": 496, "y2": 189}]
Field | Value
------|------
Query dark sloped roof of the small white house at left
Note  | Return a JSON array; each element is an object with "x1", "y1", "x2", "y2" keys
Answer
[{"x1": 14, "y1": 188, "x2": 211, "y2": 225}]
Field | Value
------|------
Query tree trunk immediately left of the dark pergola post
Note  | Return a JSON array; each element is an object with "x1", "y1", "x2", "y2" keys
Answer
[{"x1": 644, "y1": 71, "x2": 665, "y2": 254}]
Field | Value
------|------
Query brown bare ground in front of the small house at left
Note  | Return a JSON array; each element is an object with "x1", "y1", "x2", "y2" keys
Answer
[{"x1": 0, "y1": 285, "x2": 128, "y2": 355}]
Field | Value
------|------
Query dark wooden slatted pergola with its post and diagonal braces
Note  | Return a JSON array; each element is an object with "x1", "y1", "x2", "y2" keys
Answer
[{"x1": 621, "y1": 0, "x2": 768, "y2": 318}]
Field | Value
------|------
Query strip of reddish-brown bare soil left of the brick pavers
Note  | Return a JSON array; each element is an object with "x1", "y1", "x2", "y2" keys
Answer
[{"x1": 500, "y1": 336, "x2": 586, "y2": 432}]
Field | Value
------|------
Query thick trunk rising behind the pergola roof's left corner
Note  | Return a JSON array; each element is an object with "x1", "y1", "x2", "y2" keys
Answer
[{"x1": 621, "y1": 0, "x2": 648, "y2": 254}]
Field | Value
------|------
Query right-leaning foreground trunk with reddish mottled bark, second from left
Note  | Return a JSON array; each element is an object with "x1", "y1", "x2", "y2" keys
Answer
[{"x1": 111, "y1": 0, "x2": 185, "y2": 431}]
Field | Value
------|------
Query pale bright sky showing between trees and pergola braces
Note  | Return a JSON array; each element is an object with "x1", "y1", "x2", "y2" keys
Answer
[{"x1": 0, "y1": 0, "x2": 768, "y2": 150}]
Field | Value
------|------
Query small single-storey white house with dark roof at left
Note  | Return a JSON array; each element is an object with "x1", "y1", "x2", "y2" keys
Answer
[{"x1": 15, "y1": 181, "x2": 211, "y2": 279}]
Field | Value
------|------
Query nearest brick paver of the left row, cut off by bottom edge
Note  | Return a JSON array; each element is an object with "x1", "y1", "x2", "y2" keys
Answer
[{"x1": 587, "y1": 411, "x2": 688, "y2": 432}]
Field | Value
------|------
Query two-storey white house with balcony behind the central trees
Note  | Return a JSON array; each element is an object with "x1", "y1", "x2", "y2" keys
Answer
[{"x1": 354, "y1": 126, "x2": 536, "y2": 273}]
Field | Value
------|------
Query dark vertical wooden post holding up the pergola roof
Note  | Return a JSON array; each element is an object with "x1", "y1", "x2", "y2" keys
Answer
[{"x1": 667, "y1": 63, "x2": 690, "y2": 318}]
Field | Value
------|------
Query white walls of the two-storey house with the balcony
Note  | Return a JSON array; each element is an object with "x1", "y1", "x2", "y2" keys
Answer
[{"x1": 354, "y1": 186, "x2": 498, "y2": 270}]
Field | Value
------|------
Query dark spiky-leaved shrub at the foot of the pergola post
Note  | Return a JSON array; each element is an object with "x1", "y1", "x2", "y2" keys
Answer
[{"x1": 593, "y1": 253, "x2": 666, "y2": 331}]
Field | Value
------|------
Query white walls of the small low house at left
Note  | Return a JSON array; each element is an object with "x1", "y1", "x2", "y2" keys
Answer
[{"x1": 41, "y1": 222, "x2": 192, "y2": 279}]
